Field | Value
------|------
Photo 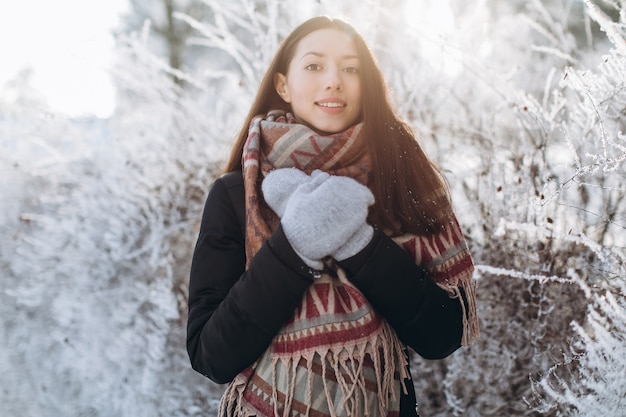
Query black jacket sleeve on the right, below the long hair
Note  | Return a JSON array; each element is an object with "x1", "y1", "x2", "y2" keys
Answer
[{"x1": 339, "y1": 230, "x2": 463, "y2": 359}]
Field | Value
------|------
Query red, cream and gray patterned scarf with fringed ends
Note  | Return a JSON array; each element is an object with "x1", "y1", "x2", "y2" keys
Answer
[{"x1": 219, "y1": 111, "x2": 478, "y2": 417}]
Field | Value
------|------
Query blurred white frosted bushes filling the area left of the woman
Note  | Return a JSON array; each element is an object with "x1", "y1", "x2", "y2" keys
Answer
[{"x1": 0, "y1": 14, "x2": 228, "y2": 416}]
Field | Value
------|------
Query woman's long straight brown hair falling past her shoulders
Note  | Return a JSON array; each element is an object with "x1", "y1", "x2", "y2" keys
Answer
[{"x1": 225, "y1": 16, "x2": 452, "y2": 235}]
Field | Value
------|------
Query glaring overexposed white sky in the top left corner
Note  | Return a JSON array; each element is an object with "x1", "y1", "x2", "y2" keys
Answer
[{"x1": 0, "y1": 0, "x2": 127, "y2": 117}]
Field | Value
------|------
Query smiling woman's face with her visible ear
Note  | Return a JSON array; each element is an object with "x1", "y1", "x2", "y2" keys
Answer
[{"x1": 274, "y1": 29, "x2": 361, "y2": 134}]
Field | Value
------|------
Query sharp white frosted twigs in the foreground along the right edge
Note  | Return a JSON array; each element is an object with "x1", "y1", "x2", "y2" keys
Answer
[{"x1": 537, "y1": 3, "x2": 626, "y2": 416}]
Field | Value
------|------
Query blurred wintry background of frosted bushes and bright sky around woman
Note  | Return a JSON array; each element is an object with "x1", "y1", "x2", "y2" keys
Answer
[{"x1": 0, "y1": 0, "x2": 626, "y2": 417}]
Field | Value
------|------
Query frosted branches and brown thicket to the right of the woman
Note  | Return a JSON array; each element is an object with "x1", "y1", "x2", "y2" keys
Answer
[{"x1": 414, "y1": 2, "x2": 626, "y2": 415}]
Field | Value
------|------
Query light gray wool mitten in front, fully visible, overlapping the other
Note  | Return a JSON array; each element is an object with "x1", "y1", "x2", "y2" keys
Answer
[{"x1": 281, "y1": 171, "x2": 374, "y2": 269}]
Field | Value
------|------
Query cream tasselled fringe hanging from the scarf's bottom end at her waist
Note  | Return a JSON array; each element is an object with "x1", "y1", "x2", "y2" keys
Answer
[{"x1": 218, "y1": 316, "x2": 410, "y2": 417}]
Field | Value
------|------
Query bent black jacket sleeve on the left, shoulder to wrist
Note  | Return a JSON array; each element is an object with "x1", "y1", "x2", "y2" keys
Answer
[{"x1": 187, "y1": 174, "x2": 313, "y2": 384}]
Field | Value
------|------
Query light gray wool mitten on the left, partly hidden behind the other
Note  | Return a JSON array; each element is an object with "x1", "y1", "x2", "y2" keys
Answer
[{"x1": 261, "y1": 168, "x2": 311, "y2": 217}]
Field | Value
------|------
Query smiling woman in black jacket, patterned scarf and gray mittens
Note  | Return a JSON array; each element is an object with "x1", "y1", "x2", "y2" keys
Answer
[{"x1": 187, "y1": 17, "x2": 478, "y2": 416}]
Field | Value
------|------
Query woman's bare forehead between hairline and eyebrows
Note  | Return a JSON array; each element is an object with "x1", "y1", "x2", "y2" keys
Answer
[{"x1": 294, "y1": 28, "x2": 357, "y2": 59}]
